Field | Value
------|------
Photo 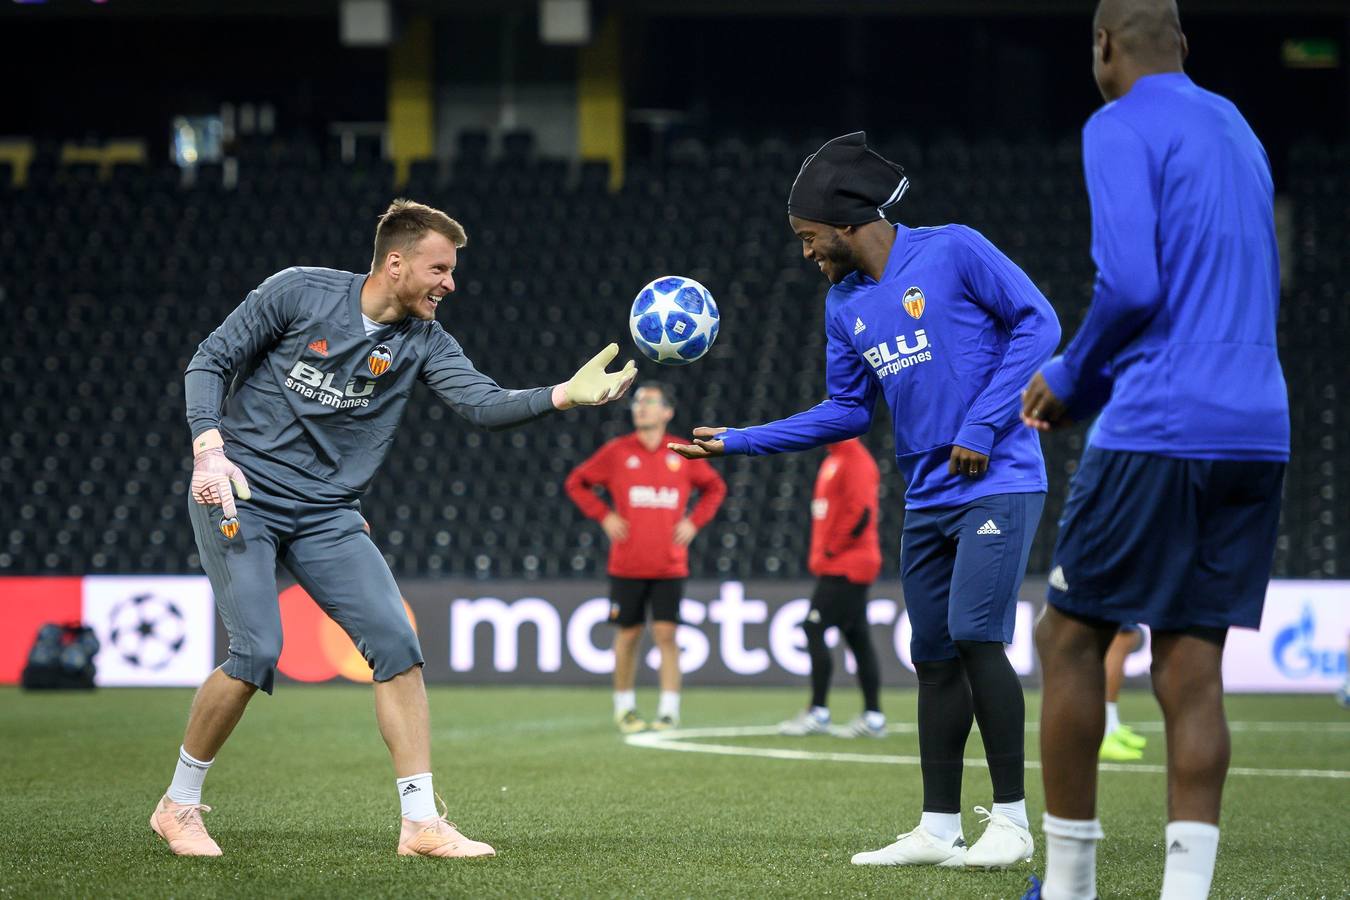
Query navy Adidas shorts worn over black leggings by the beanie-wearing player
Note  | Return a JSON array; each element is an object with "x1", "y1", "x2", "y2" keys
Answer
[{"x1": 900, "y1": 494, "x2": 1045, "y2": 663}]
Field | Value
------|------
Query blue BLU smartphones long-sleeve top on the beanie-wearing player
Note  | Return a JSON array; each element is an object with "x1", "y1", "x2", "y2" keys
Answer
[{"x1": 722, "y1": 225, "x2": 1060, "y2": 509}]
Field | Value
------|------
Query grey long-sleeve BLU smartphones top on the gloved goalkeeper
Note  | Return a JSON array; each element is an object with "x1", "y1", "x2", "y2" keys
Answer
[{"x1": 185, "y1": 267, "x2": 554, "y2": 502}]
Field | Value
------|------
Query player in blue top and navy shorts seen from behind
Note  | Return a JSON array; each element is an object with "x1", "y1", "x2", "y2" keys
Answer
[{"x1": 1022, "y1": 0, "x2": 1289, "y2": 900}]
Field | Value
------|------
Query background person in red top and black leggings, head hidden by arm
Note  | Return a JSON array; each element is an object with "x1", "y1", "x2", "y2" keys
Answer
[{"x1": 779, "y1": 437, "x2": 886, "y2": 738}]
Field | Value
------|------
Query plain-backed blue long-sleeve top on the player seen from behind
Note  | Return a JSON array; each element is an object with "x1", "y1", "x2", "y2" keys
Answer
[{"x1": 1044, "y1": 73, "x2": 1289, "y2": 460}]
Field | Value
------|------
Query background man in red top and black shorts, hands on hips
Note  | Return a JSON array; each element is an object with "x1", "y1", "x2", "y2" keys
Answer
[{"x1": 566, "y1": 382, "x2": 726, "y2": 734}]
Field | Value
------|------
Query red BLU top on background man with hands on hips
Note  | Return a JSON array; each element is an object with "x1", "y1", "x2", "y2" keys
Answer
[{"x1": 563, "y1": 432, "x2": 726, "y2": 579}]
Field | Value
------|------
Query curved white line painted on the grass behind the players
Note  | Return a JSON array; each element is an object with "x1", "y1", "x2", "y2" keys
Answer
[{"x1": 624, "y1": 723, "x2": 1350, "y2": 779}]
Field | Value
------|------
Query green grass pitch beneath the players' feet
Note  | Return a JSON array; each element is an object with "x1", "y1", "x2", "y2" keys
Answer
[{"x1": 0, "y1": 685, "x2": 1350, "y2": 899}]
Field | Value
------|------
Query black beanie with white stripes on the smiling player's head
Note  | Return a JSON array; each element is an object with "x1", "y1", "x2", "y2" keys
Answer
[{"x1": 787, "y1": 131, "x2": 910, "y2": 227}]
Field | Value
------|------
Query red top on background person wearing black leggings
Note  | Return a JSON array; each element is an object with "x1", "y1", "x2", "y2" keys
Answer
[{"x1": 810, "y1": 437, "x2": 882, "y2": 584}]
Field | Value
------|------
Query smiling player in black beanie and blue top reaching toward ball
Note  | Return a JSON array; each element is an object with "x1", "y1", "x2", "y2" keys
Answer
[{"x1": 672, "y1": 132, "x2": 1060, "y2": 866}]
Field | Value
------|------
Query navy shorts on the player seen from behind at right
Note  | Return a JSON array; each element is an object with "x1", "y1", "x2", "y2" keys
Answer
[{"x1": 1049, "y1": 447, "x2": 1285, "y2": 631}]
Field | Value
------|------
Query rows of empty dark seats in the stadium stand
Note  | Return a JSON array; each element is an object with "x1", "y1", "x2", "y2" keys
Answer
[{"x1": 0, "y1": 132, "x2": 1350, "y2": 578}]
